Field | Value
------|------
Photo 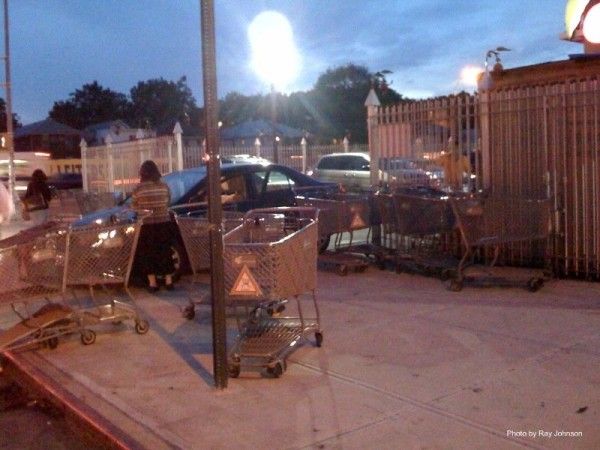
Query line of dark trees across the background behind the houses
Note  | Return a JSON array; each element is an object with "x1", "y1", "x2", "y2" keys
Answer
[{"x1": 0, "y1": 64, "x2": 407, "y2": 143}]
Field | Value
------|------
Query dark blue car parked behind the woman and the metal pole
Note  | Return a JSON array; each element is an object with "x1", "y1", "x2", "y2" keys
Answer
[{"x1": 73, "y1": 163, "x2": 338, "y2": 282}]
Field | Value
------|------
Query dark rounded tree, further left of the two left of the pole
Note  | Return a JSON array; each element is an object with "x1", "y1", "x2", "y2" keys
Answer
[{"x1": 48, "y1": 81, "x2": 130, "y2": 130}]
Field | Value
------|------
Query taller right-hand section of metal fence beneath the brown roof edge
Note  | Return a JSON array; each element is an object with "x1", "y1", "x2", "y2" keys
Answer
[{"x1": 481, "y1": 76, "x2": 600, "y2": 279}]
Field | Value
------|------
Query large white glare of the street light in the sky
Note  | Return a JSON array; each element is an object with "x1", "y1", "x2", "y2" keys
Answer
[{"x1": 248, "y1": 11, "x2": 300, "y2": 90}]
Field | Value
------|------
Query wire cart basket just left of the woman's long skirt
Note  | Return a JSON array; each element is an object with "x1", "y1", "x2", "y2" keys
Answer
[{"x1": 65, "y1": 219, "x2": 142, "y2": 286}]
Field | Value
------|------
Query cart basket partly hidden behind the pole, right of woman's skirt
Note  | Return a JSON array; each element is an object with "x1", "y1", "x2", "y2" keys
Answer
[{"x1": 175, "y1": 211, "x2": 244, "y2": 274}]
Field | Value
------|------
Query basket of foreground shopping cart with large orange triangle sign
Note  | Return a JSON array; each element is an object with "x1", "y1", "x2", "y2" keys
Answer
[{"x1": 223, "y1": 207, "x2": 318, "y2": 302}]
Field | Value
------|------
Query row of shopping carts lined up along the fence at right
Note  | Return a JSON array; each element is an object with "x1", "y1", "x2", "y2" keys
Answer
[{"x1": 297, "y1": 187, "x2": 550, "y2": 291}]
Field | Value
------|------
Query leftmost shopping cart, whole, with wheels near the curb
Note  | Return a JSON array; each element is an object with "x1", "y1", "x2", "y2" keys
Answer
[{"x1": 0, "y1": 229, "x2": 95, "y2": 351}]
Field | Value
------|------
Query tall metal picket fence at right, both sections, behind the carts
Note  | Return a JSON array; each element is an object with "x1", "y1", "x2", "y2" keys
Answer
[{"x1": 369, "y1": 75, "x2": 600, "y2": 280}]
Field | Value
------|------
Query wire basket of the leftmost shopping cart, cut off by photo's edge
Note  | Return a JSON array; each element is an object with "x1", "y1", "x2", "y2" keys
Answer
[{"x1": 0, "y1": 229, "x2": 68, "y2": 305}]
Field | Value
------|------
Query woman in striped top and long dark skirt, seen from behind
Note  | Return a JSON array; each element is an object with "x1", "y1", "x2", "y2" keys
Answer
[{"x1": 132, "y1": 160, "x2": 175, "y2": 292}]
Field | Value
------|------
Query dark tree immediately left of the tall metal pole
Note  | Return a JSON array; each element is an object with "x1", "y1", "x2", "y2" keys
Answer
[{"x1": 130, "y1": 76, "x2": 200, "y2": 128}]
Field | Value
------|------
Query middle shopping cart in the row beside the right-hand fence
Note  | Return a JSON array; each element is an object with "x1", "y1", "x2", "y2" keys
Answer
[{"x1": 375, "y1": 193, "x2": 455, "y2": 279}]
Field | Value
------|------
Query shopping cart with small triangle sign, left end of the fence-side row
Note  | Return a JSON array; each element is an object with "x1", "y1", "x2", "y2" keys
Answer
[{"x1": 296, "y1": 194, "x2": 375, "y2": 276}]
